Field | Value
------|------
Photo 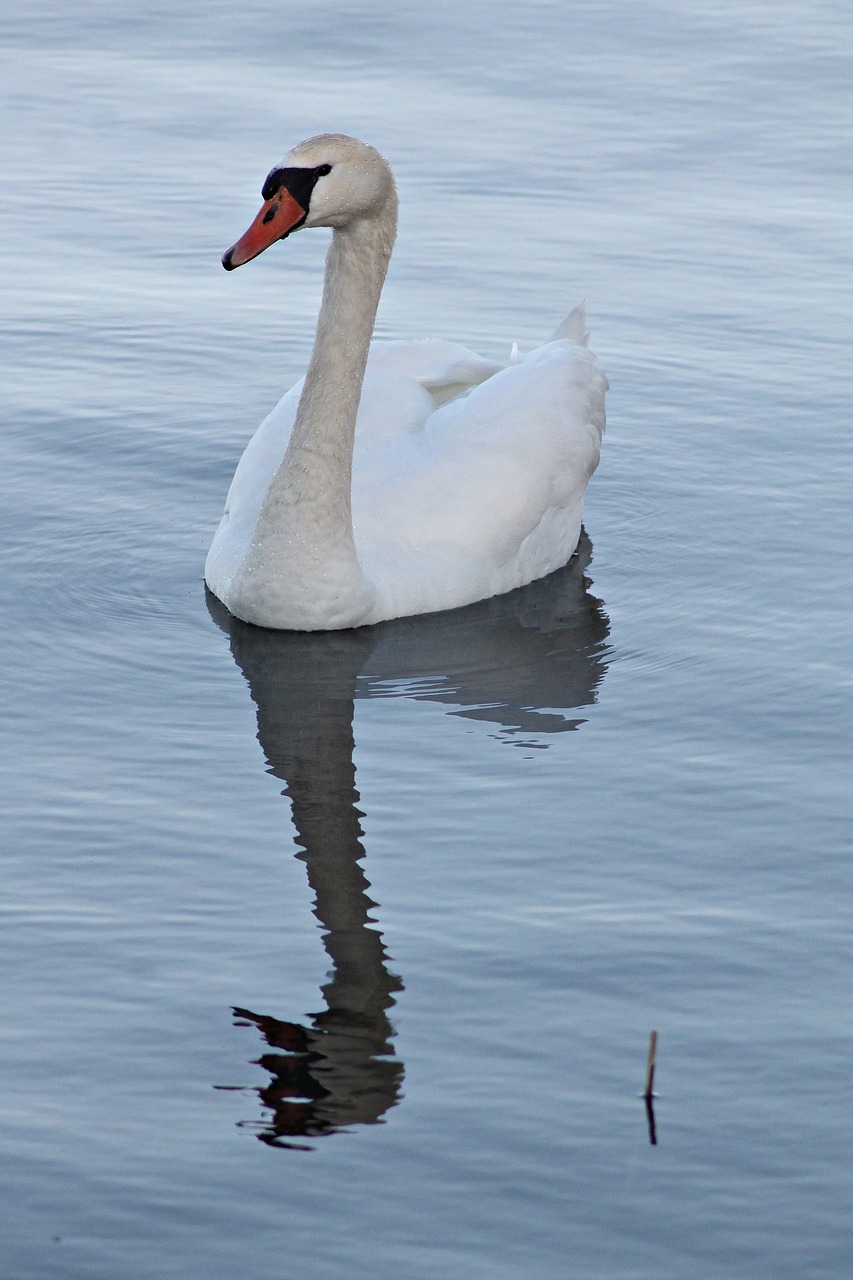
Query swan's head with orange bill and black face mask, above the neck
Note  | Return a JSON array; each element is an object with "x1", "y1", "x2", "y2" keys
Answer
[{"x1": 222, "y1": 133, "x2": 397, "y2": 271}]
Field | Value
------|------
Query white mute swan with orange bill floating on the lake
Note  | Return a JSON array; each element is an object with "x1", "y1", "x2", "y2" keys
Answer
[{"x1": 205, "y1": 134, "x2": 607, "y2": 631}]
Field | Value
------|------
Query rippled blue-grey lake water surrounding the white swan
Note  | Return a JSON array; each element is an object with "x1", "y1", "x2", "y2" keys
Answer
[{"x1": 0, "y1": 0, "x2": 853, "y2": 1280}]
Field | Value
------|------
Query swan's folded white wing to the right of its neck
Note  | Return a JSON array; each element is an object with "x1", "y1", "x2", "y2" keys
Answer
[{"x1": 352, "y1": 338, "x2": 607, "y2": 621}]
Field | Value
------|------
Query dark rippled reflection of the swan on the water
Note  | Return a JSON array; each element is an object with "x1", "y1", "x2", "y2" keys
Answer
[{"x1": 207, "y1": 535, "x2": 608, "y2": 1146}]
